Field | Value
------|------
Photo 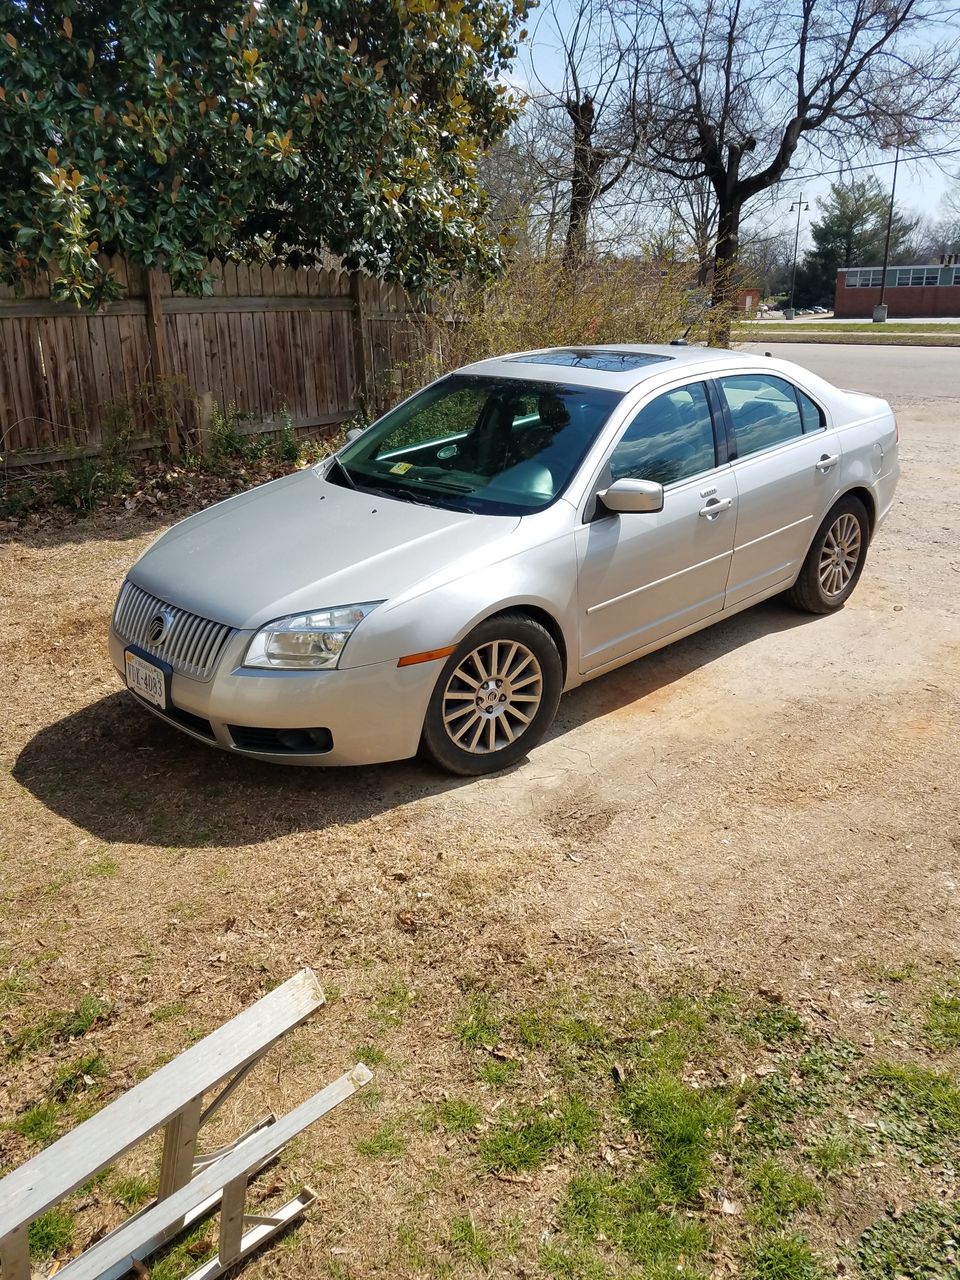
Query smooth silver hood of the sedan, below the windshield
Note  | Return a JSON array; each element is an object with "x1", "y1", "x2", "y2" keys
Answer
[{"x1": 129, "y1": 468, "x2": 518, "y2": 628}]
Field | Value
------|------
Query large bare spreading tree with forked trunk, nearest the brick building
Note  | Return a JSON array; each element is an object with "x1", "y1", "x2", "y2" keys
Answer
[{"x1": 627, "y1": 0, "x2": 960, "y2": 330}]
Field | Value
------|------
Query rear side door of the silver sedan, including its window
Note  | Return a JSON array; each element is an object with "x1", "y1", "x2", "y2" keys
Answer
[{"x1": 717, "y1": 372, "x2": 841, "y2": 608}]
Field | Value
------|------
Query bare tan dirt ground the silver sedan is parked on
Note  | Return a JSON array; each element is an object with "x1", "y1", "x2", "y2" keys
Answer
[{"x1": 0, "y1": 389, "x2": 960, "y2": 1276}]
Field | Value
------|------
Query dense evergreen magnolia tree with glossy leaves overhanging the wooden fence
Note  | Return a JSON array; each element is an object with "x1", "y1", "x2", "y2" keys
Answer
[{"x1": 0, "y1": 0, "x2": 527, "y2": 306}]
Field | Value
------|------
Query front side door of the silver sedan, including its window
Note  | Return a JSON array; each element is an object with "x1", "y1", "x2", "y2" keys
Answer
[{"x1": 577, "y1": 383, "x2": 737, "y2": 673}]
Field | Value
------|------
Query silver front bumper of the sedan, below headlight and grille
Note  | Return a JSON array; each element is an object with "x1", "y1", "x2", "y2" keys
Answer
[{"x1": 110, "y1": 627, "x2": 442, "y2": 765}]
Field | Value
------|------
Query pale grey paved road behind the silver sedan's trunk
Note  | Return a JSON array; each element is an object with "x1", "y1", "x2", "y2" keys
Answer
[{"x1": 744, "y1": 342, "x2": 960, "y2": 406}]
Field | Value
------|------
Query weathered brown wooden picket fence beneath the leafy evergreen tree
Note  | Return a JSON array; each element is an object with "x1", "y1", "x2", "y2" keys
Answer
[{"x1": 0, "y1": 257, "x2": 419, "y2": 467}]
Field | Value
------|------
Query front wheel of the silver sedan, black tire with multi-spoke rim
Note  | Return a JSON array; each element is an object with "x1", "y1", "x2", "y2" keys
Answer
[{"x1": 420, "y1": 613, "x2": 563, "y2": 777}]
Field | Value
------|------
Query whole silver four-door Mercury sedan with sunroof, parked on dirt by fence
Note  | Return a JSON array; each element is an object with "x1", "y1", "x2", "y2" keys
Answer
[{"x1": 110, "y1": 346, "x2": 899, "y2": 774}]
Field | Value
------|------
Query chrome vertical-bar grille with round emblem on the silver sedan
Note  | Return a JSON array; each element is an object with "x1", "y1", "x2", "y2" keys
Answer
[{"x1": 114, "y1": 582, "x2": 233, "y2": 680}]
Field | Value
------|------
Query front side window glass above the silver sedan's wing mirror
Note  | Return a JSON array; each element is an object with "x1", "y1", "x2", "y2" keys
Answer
[{"x1": 609, "y1": 383, "x2": 717, "y2": 485}]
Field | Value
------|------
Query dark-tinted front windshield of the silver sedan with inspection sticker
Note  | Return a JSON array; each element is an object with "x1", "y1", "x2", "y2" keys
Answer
[{"x1": 328, "y1": 374, "x2": 621, "y2": 515}]
